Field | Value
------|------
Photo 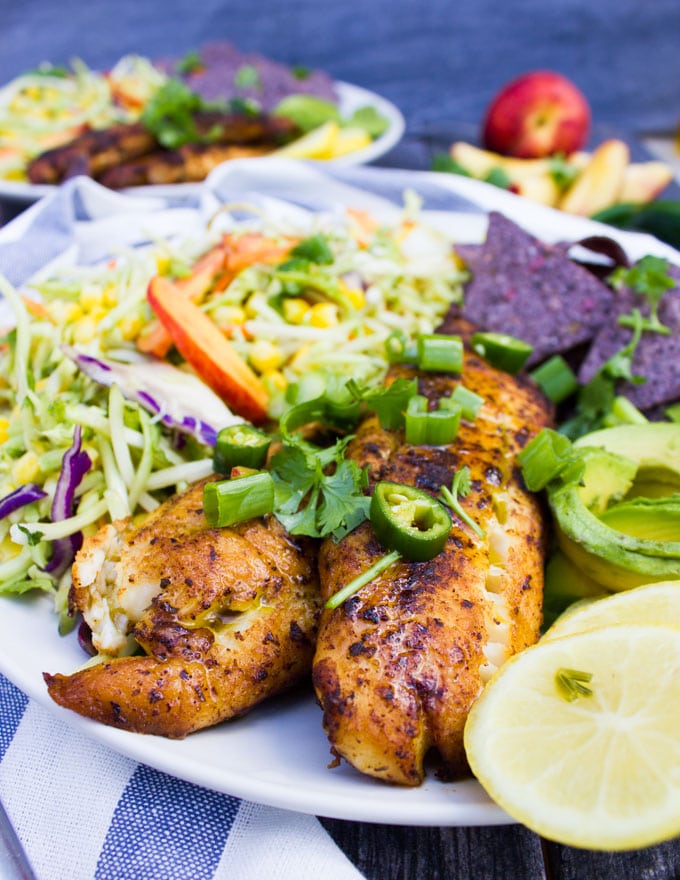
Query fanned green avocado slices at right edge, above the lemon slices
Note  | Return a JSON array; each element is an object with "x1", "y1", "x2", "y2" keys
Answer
[{"x1": 548, "y1": 422, "x2": 680, "y2": 590}]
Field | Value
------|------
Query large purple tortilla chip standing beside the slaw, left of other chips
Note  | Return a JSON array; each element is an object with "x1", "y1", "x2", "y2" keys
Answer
[{"x1": 463, "y1": 212, "x2": 614, "y2": 366}]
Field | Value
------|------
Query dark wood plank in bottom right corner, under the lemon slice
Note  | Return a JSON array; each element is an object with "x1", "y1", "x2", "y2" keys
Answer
[{"x1": 545, "y1": 838, "x2": 680, "y2": 880}]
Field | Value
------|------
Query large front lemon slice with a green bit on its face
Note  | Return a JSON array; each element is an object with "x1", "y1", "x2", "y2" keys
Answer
[{"x1": 465, "y1": 625, "x2": 680, "y2": 850}]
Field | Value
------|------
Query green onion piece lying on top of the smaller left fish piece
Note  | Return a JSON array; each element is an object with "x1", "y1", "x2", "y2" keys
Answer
[{"x1": 203, "y1": 471, "x2": 274, "y2": 529}]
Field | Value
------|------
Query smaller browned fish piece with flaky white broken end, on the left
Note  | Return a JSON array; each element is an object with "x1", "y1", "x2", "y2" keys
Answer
[{"x1": 44, "y1": 482, "x2": 319, "y2": 737}]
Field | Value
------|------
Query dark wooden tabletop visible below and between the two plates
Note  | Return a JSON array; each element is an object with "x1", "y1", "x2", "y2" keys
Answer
[{"x1": 0, "y1": 127, "x2": 680, "y2": 880}]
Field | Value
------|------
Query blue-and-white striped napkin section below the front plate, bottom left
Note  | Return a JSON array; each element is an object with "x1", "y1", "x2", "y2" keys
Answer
[{"x1": 0, "y1": 676, "x2": 363, "y2": 880}]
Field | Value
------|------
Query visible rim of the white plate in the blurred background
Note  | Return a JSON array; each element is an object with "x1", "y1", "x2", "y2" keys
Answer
[{"x1": 0, "y1": 81, "x2": 406, "y2": 204}]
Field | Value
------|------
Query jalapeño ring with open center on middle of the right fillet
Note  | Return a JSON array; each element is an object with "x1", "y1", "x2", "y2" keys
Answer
[{"x1": 369, "y1": 481, "x2": 451, "y2": 562}]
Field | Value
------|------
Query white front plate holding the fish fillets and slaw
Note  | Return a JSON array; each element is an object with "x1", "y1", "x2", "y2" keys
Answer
[{"x1": 0, "y1": 159, "x2": 680, "y2": 826}]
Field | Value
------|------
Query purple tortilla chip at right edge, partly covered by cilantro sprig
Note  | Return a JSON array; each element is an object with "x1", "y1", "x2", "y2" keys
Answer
[{"x1": 578, "y1": 266, "x2": 680, "y2": 410}]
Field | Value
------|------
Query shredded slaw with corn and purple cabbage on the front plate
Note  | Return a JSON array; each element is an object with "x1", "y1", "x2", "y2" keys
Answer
[{"x1": 0, "y1": 195, "x2": 466, "y2": 629}]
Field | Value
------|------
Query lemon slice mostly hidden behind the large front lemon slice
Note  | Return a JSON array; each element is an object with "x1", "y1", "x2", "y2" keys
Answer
[{"x1": 543, "y1": 581, "x2": 680, "y2": 639}]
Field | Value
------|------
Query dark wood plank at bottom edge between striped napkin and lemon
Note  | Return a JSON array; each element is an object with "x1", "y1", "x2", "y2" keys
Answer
[{"x1": 320, "y1": 819, "x2": 548, "y2": 880}]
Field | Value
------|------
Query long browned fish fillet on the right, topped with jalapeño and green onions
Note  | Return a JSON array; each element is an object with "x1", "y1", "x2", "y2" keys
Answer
[{"x1": 313, "y1": 327, "x2": 550, "y2": 785}]
